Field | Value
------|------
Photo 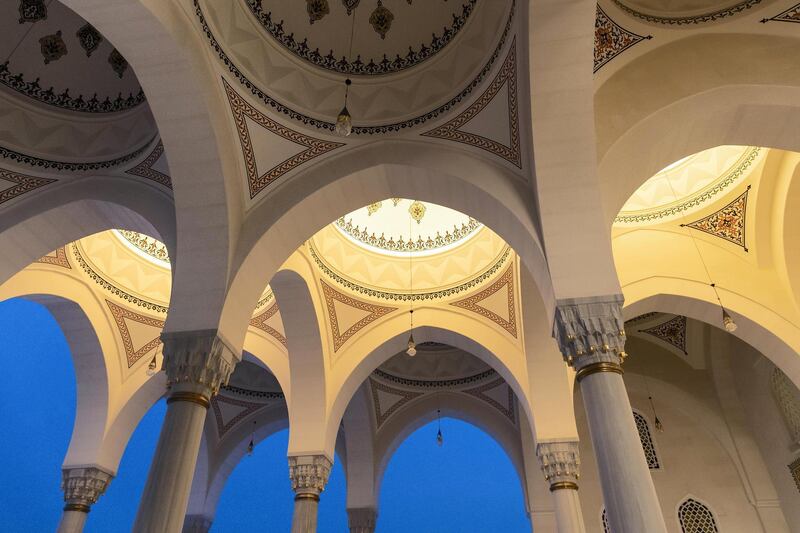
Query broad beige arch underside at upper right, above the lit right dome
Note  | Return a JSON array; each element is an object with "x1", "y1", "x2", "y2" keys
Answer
[{"x1": 595, "y1": 34, "x2": 800, "y2": 222}]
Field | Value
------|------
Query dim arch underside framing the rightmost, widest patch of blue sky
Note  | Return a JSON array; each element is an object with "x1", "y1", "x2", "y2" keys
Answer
[{"x1": 375, "y1": 391, "x2": 525, "y2": 501}]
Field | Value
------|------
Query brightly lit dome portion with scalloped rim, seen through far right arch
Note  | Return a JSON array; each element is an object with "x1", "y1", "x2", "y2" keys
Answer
[{"x1": 614, "y1": 146, "x2": 763, "y2": 224}]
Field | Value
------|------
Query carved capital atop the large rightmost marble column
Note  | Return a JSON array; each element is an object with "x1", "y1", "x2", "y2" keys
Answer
[{"x1": 553, "y1": 294, "x2": 626, "y2": 372}]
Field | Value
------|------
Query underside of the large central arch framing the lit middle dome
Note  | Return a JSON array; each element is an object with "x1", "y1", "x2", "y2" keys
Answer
[{"x1": 221, "y1": 140, "x2": 554, "y2": 346}]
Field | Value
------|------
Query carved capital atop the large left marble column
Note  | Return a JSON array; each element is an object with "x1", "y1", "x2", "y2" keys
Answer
[{"x1": 161, "y1": 331, "x2": 239, "y2": 395}]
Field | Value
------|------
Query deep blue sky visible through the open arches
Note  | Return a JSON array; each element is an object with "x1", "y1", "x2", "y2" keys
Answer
[{"x1": 0, "y1": 300, "x2": 530, "y2": 533}]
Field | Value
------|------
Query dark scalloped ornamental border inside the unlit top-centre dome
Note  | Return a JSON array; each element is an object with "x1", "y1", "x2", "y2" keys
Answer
[{"x1": 246, "y1": 0, "x2": 478, "y2": 75}]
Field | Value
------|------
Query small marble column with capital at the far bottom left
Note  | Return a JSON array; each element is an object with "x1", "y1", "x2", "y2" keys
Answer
[{"x1": 57, "y1": 466, "x2": 114, "y2": 533}]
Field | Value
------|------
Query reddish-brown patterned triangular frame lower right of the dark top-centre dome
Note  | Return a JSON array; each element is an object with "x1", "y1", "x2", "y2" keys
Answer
[{"x1": 421, "y1": 38, "x2": 522, "y2": 168}]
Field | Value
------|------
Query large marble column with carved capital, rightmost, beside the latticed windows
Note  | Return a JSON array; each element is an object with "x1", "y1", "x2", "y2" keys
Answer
[{"x1": 553, "y1": 295, "x2": 666, "y2": 533}]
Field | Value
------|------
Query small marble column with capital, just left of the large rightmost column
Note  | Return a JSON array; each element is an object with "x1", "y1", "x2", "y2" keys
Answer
[{"x1": 536, "y1": 441, "x2": 586, "y2": 533}]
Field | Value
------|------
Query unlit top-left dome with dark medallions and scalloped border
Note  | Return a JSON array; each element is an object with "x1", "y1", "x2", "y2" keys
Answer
[{"x1": 0, "y1": 0, "x2": 145, "y2": 113}]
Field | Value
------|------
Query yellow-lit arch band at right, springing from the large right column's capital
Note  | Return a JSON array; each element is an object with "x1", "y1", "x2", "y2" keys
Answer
[{"x1": 623, "y1": 286, "x2": 800, "y2": 386}]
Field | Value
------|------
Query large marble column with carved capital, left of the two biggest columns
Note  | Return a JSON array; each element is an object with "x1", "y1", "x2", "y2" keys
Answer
[{"x1": 133, "y1": 332, "x2": 238, "y2": 533}]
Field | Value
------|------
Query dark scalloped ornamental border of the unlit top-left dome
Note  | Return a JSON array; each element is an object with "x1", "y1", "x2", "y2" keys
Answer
[{"x1": 0, "y1": 61, "x2": 147, "y2": 114}]
